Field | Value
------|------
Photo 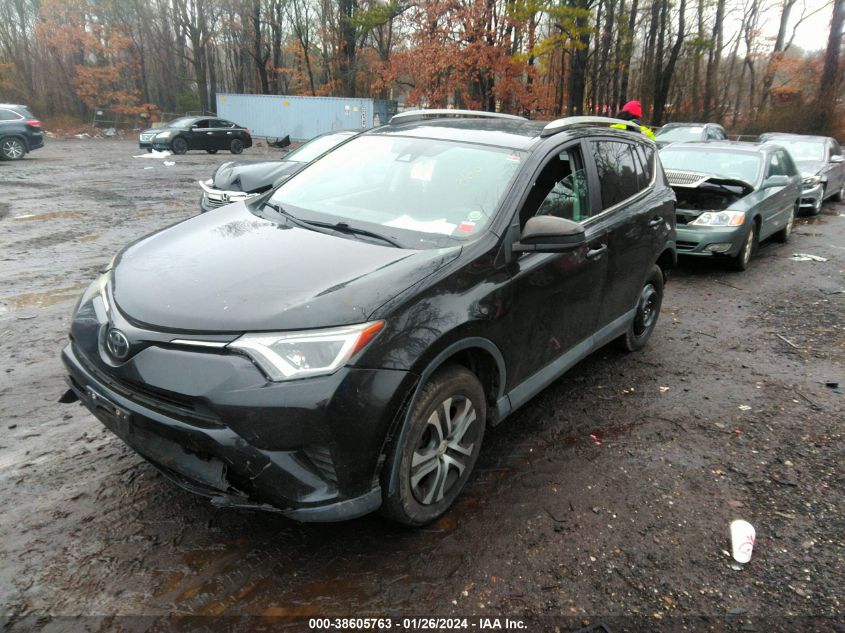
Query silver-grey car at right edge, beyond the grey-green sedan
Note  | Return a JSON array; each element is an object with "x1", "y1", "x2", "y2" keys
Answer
[{"x1": 757, "y1": 133, "x2": 845, "y2": 215}]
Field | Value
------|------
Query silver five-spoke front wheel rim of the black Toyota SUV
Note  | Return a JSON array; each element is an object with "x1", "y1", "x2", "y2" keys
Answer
[{"x1": 410, "y1": 396, "x2": 479, "y2": 505}]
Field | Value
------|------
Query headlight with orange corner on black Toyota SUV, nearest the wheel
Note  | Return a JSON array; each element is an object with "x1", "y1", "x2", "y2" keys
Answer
[{"x1": 228, "y1": 321, "x2": 384, "y2": 382}]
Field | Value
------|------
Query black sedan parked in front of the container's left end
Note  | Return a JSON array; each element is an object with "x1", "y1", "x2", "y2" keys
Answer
[{"x1": 138, "y1": 116, "x2": 252, "y2": 154}]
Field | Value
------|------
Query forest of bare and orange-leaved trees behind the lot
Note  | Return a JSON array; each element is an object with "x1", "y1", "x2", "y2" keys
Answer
[{"x1": 0, "y1": 0, "x2": 845, "y2": 135}]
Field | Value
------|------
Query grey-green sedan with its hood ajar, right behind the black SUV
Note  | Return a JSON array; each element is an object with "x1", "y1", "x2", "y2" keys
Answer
[{"x1": 660, "y1": 141, "x2": 801, "y2": 270}]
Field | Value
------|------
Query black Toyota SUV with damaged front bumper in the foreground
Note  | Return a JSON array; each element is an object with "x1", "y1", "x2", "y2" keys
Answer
[{"x1": 62, "y1": 110, "x2": 676, "y2": 525}]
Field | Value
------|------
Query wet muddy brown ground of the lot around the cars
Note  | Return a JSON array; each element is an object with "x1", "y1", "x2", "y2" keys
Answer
[{"x1": 0, "y1": 140, "x2": 845, "y2": 631}]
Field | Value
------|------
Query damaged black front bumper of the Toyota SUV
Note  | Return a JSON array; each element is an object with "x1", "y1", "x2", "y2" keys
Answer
[{"x1": 62, "y1": 343, "x2": 409, "y2": 521}]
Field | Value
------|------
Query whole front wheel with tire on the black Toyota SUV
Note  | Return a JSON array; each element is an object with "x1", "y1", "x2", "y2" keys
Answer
[{"x1": 381, "y1": 365, "x2": 487, "y2": 527}]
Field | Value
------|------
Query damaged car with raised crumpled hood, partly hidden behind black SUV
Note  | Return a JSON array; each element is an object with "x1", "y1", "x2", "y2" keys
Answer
[{"x1": 200, "y1": 130, "x2": 357, "y2": 213}]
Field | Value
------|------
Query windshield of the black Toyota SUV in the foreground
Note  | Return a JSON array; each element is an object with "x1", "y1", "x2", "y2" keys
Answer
[{"x1": 271, "y1": 135, "x2": 523, "y2": 243}]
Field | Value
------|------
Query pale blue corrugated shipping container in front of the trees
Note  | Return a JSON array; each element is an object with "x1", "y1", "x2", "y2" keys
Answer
[{"x1": 211, "y1": 94, "x2": 396, "y2": 141}]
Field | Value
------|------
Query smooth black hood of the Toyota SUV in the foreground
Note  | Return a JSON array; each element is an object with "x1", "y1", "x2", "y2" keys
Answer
[{"x1": 112, "y1": 203, "x2": 461, "y2": 332}]
